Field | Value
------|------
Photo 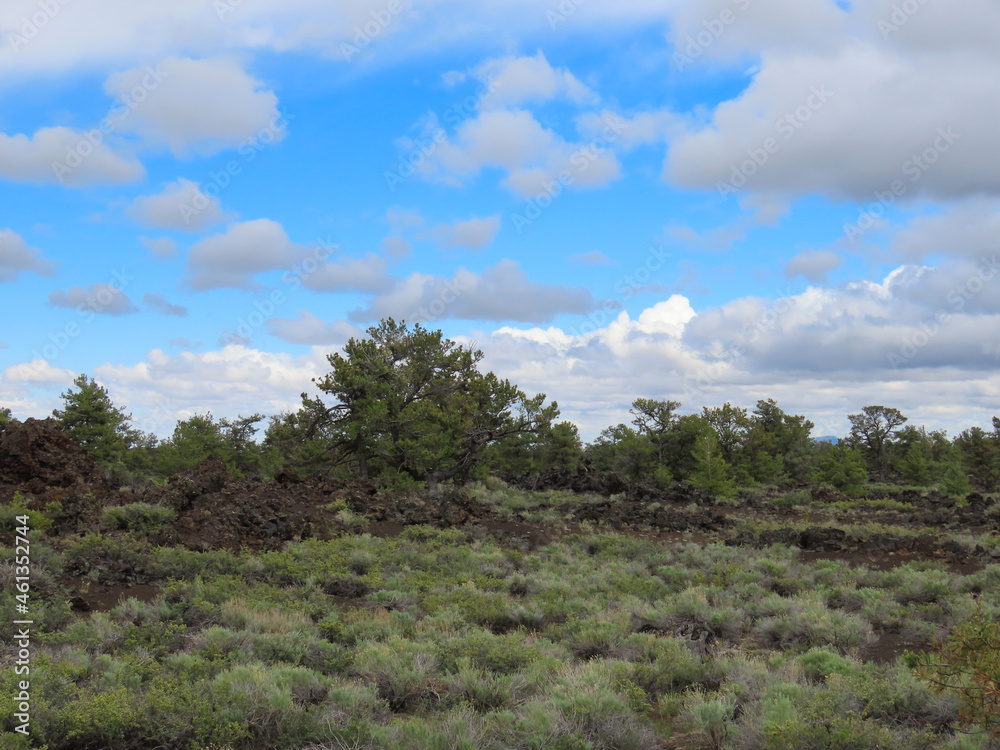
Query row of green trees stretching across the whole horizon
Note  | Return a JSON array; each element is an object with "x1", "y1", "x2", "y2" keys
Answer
[{"x1": 0, "y1": 318, "x2": 1000, "y2": 497}]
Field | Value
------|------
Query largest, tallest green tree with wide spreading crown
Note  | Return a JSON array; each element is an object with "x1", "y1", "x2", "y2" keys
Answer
[{"x1": 315, "y1": 318, "x2": 559, "y2": 488}]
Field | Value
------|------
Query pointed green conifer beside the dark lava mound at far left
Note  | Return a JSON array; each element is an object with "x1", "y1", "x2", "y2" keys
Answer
[{"x1": 52, "y1": 375, "x2": 139, "y2": 464}]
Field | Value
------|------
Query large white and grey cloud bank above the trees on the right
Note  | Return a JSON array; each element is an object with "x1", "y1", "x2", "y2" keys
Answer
[{"x1": 476, "y1": 268, "x2": 1000, "y2": 439}]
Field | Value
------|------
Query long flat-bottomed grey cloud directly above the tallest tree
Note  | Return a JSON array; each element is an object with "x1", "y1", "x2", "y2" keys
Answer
[{"x1": 350, "y1": 260, "x2": 595, "y2": 322}]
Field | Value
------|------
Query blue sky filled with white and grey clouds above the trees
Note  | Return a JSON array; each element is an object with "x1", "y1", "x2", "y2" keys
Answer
[{"x1": 0, "y1": 0, "x2": 1000, "y2": 440}]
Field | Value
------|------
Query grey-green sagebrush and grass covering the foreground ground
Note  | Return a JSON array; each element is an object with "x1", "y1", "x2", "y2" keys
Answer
[{"x1": 0, "y1": 482, "x2": 1000, "y2": 750}]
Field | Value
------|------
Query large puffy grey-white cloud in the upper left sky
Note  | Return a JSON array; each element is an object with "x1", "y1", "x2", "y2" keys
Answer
[{"x1": 104, "y1": 57, "x2": 285, "y2": 156}]
